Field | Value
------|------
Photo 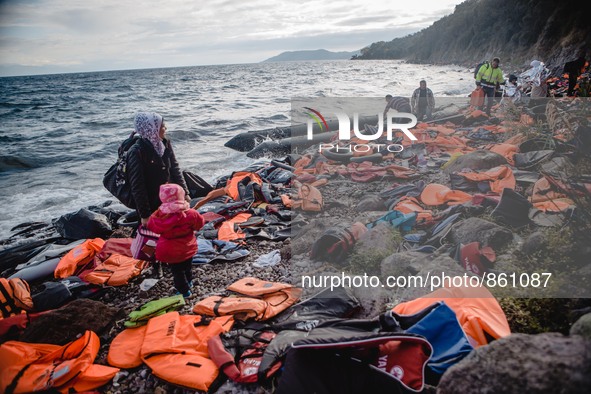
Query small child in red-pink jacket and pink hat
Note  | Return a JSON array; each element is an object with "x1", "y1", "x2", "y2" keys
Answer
[{"x1": 148, "y1": 183, "x2": 204, "y2": 298}]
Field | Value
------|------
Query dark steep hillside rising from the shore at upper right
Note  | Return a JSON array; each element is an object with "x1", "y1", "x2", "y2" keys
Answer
[{"x1": 355, "y1": 0, "x2": 591, "y2": 72}]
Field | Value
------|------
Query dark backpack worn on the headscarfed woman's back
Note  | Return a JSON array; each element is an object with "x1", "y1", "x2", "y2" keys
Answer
[{"x1": 103, "y1": 132, "x2": 139, "y2": 209}]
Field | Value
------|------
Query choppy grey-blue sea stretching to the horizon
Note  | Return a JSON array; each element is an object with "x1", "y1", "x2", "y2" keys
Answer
[{"x1": 0, "y1": 60, "x2": 474, "y2": 239}]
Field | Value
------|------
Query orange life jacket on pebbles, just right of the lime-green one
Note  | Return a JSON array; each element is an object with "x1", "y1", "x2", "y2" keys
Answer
[{"x1": 193, "y1": 277, "x2": 302, "y2": 320}]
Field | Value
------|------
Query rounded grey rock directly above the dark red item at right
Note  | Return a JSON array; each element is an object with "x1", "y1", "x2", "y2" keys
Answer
[{"x1": 451, "y1": 218, "x2": 513, "y2": 250}]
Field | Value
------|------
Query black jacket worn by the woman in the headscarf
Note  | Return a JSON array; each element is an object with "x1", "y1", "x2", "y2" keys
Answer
[{"x1": 127, "y1": 138, "x2": 188, "y2": 218}]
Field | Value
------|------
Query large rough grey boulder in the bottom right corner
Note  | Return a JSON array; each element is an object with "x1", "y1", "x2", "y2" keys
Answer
[{"x1": 437, "y1": 333, "x2": 591, "y2": 394}]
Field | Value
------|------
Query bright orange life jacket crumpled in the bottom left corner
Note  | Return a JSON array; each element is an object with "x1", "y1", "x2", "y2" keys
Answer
[{"x1": 0, "y1": 331, "x2": 119, "y2": 393}]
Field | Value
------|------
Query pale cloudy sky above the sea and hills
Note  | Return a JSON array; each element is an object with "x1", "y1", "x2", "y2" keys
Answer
[{"x1": 0, "y1": 0, "x2": 463, "y2": 76}]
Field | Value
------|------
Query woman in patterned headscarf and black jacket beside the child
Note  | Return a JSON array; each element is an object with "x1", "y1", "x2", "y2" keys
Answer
[{"x1": 127, "y1": 112, "x2": 190, "y2": 225}]
